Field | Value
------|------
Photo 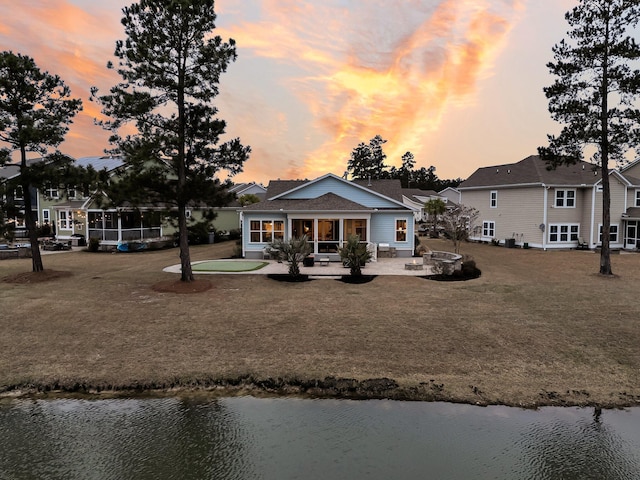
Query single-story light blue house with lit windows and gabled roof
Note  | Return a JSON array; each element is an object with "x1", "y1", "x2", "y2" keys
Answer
[{"x1": 239, "y1": 173, "x2": 416, "y2": 261}]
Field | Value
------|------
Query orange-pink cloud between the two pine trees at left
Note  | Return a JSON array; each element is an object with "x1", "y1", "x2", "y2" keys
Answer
[{"x1": 0, "y1": 0, "x2": 129, "y2": 156}]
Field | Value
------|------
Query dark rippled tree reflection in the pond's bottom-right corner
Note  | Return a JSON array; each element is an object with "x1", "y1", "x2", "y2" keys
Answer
[{"x1": 517, "y1": 411, "x2": 640, "y2": 480}]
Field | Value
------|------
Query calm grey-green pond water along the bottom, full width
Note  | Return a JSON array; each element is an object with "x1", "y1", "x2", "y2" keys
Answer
[{"x1": 0, "y1": 397, "x2": 640, "y2": 480}]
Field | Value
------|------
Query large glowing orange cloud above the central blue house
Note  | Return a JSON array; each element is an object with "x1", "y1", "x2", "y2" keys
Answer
[{"x1": 220, "y1": 0, "x2": 522, "y2": 177}]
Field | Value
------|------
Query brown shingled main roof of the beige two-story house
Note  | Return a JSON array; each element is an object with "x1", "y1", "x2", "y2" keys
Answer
[{"x1": 458, "y1": 155, "x2": 600, "y2": 190}]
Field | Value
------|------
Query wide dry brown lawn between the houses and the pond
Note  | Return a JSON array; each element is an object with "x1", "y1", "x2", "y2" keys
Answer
[{"x1": 0, "y1": 240, "x2": 640, "y2": 406}]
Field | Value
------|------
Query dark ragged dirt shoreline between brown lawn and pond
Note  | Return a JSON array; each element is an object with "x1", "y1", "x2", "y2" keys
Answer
[{"x1": 0, "y1": 376, "x2": 640, "y2": 409}]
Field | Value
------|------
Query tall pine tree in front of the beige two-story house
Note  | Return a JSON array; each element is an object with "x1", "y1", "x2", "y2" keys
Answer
[{"x1": 538, "y1": 0, "x2": 640, "y2": 275}]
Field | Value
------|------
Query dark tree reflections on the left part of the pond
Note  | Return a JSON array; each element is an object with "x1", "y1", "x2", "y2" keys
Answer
[{"x1": 0, "y1": 399, "x2": 252, "y2": 480}]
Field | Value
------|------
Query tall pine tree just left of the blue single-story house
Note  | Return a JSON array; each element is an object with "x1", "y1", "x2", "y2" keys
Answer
[{"x1": 93, "y1": 0, "x2": 250, "y2": 282}]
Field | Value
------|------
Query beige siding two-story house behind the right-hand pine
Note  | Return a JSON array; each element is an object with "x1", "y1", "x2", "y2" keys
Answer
[{"x1": 459, "y1": 155, "x2": 640, "y2": 249}]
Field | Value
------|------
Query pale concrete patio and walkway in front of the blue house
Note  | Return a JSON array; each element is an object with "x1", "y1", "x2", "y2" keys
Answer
[{"x1": 163, "y1": 258, "x2": 433, "y2": 277}]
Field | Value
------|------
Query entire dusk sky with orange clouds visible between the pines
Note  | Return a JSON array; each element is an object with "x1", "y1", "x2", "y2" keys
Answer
[{"x1": 0, "y1": 0, "x2": 577, "y2": 184}]
